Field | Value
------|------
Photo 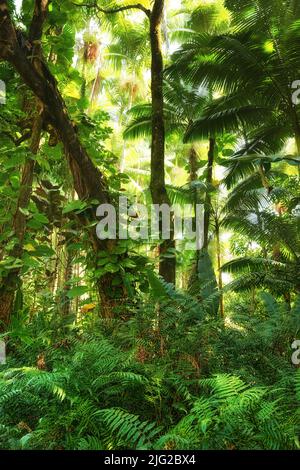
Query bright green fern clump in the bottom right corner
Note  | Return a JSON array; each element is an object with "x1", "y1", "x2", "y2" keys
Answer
[{"x1": 157, "y1": 374, "x2": 299, "y2": 450}]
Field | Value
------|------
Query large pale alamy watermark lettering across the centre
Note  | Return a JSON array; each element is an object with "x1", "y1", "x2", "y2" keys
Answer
[{"x1": 96, "y1": 196, "x2": 204, "y2": 250}]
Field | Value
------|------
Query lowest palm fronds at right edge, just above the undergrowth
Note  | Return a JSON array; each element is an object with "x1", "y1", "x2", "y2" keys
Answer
[{"x1": 222, "y1": 211, "x2": 300, "y2": 301}]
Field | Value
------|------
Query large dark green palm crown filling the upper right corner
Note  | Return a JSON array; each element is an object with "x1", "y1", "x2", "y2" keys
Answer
[{"x1": 168, "y1": 0, "x2": 300, "y2": 158}]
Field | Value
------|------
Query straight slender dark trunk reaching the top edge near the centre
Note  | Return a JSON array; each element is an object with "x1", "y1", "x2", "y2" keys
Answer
[{"x1": 150, "y1": 0, "x2": 176, "y2": 284}]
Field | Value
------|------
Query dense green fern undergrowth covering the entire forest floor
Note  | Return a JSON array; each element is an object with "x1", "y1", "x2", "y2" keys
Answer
[{"x1": 0, "y1": 302, "x2": 300, "y2": 450}]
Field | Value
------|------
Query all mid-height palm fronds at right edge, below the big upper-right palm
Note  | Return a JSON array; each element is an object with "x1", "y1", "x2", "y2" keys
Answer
[{"x1": 218, "y1": 151, "x2": 300, "y2": 301}]
